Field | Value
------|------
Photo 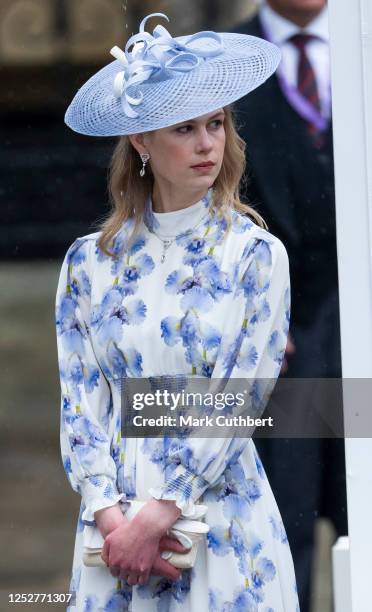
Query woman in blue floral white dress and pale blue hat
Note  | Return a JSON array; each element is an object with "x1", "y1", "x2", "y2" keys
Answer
[{"x1": 57, "y1": 14, "x2": 298, "y2": 612}]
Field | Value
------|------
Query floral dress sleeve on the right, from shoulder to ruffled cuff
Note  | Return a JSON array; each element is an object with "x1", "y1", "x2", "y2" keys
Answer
[{"x1": 150, "y1": 231, "x2": 290, "y2": 516}]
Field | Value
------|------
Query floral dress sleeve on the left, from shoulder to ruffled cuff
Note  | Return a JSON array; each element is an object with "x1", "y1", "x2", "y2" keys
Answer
[{"x1": 56, "y1": 238, "x2": 123, "y2": 521}]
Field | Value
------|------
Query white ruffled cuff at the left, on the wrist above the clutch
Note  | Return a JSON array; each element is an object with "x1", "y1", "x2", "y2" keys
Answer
[{"x1": 79, "y1": 476, "x2": 125, "y2": 524}]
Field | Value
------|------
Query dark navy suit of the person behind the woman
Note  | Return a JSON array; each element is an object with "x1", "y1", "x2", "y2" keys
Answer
[{"x1": 234, "y1": 16, "x2": 352, "y2": 548}]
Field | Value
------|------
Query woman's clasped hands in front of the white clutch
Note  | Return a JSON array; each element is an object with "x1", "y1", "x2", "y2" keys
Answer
[{"x1": 95, "y1": 499, "x2": 188, "y2": 586}]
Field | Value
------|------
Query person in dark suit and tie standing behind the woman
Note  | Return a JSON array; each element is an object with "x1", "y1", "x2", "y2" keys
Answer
[{"x1": 234, "y1": 0, "x2": 347, "y2": 612}]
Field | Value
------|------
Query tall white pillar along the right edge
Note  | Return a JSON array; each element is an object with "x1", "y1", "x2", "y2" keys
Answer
[{"x1": 329, "y1": 0, "x2": 372, "y2": 612}]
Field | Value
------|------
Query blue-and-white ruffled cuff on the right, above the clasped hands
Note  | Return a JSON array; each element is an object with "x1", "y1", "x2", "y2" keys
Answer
[{"x1": 149, "y1": 465, "x2": 209, "y2": 519}]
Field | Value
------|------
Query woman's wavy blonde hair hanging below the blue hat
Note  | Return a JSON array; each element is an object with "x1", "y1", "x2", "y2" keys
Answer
[{"x1": 98, "y1": 107, "x2": 267, "y2": 257}]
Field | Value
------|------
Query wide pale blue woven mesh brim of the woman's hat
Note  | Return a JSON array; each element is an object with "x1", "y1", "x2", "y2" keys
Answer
[{"x1": 65, "y1": 34, "x2": 280, "y2": 136}]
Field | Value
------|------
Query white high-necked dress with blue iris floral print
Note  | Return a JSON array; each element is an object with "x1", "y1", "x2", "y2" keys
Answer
[{"x1": 56, "y1": 191, "x2": 299, "y2": 612}]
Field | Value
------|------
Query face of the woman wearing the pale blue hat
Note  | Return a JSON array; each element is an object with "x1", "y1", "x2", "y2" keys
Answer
[{"x1": 141, "y1": 108, "x2": 226, "y2": 191}]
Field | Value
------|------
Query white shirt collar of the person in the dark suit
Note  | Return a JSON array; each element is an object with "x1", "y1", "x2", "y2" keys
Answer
[{"x1": 260, "y1": 2, "x2": 329, "y2": 46}]
